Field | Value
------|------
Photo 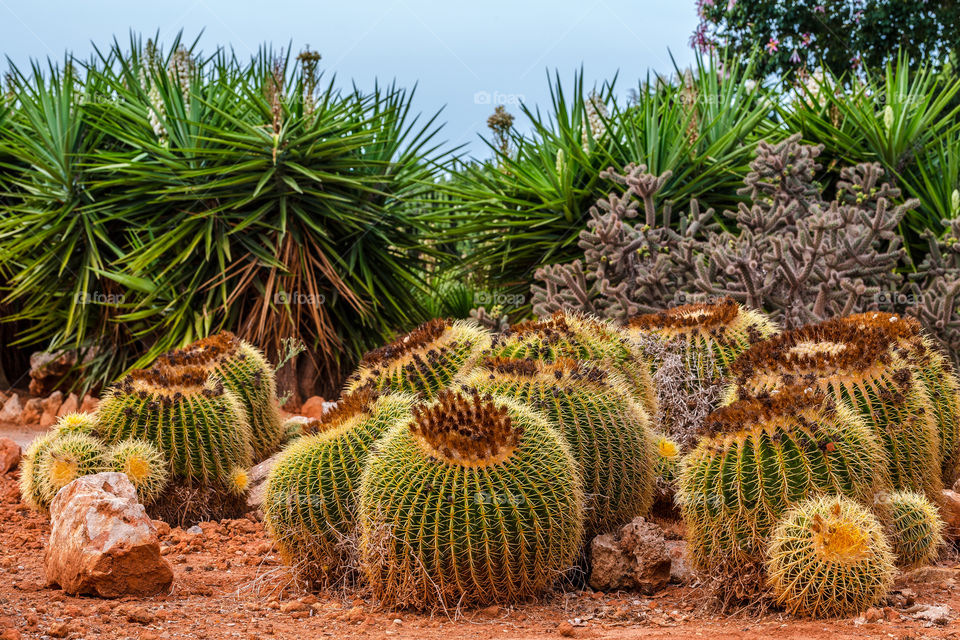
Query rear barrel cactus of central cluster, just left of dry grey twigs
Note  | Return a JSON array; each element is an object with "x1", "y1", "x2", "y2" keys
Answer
[{"x1": 491, "y1": 311, "x2": 657, "y2": 416}]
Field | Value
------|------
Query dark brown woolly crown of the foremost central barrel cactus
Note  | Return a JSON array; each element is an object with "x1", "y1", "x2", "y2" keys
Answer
[{"x1": 410, "y1": 390, "x2": 523, "y2": 467}]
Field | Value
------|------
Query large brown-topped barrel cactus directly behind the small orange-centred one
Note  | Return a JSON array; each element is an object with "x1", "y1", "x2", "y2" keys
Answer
[{"x1": 678, "y1": 386, "x2": 888, "y2": 570}]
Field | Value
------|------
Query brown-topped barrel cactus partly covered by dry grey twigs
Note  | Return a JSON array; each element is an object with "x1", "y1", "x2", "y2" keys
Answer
[{"x1": 627, "y1": 298, "x2": 780, "y2": 380}]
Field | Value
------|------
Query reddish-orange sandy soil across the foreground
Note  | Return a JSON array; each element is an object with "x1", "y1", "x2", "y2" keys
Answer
[{"x1": 0, "y1": 430, "x2": 960, "y2": 640}]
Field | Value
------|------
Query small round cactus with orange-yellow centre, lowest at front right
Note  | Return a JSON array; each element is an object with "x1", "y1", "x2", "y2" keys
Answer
[{"x1": 766, "y1": 496, "x2": 894, "y2": 618}]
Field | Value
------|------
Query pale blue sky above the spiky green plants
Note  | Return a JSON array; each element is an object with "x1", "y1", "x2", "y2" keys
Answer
[{"x1": 0, "y1": 0, "x2": 697, "y2": 155}]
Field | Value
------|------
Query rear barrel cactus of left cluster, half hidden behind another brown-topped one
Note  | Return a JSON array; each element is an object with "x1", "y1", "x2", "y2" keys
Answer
[{"x1": 155, "y1": 331, "x2": 285, "y2": 460}]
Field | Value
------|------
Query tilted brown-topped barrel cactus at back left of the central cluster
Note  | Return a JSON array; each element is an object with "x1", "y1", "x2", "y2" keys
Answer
[{"x1": 346, "y1": 319, "x2": 491, "y2": 397}]
